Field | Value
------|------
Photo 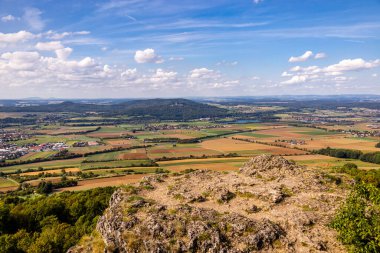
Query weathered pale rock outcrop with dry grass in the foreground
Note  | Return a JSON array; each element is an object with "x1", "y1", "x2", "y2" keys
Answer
[{"x1": 71, "y1": 155, "x2": 346, "y2": 253}]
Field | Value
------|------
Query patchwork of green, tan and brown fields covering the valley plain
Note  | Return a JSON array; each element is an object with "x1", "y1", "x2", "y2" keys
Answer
[{"x1": 0, "y1": 121, "x2": 380, "y2": 191}]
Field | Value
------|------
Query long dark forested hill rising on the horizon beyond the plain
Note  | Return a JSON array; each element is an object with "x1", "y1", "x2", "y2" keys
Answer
[{"x1": 0, "y1": 99, "x2": 227, "y2": 120}]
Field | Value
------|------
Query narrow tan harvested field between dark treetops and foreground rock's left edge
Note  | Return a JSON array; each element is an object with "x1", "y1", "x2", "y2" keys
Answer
[{"x1": 58, "y1": 174, "x2": 146, "y2": 191}]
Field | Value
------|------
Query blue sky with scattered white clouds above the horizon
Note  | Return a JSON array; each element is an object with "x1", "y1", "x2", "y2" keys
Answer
[{"x1": 0, "y1": 0, "x2": 380, "y2": 99}]
